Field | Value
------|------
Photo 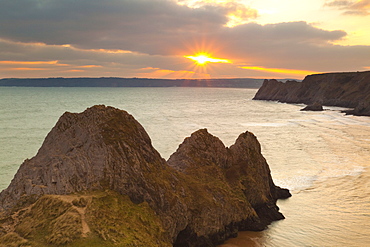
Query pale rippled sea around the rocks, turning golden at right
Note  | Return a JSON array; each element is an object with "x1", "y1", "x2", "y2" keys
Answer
[{"x1": 0, "y1": 87, "x2": 370, "y2": 247}]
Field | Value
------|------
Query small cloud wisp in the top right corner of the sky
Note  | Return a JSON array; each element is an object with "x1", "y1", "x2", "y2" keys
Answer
[{"x1": 325, "y1": 0, "x2": 370, "y2": 15}]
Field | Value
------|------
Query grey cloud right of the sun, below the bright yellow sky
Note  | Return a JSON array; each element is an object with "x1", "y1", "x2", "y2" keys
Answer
[{"x1": 207, "y1": 22, "x2": 356, "y2": 70}]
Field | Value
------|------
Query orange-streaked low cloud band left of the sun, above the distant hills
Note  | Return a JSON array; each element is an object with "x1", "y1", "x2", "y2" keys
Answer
[{"x1": 0, "y1": 37, "x2": 189, "y2": 77}]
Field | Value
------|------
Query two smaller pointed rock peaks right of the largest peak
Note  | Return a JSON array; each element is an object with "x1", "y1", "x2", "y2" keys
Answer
[{"x1": 168, "y1": 129, "x2": 290, "y2": 230}]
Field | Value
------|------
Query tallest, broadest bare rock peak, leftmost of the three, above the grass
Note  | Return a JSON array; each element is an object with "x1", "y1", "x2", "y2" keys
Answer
[{"x1": 0, "y1": 105, "x2": 167, "y2": 211}]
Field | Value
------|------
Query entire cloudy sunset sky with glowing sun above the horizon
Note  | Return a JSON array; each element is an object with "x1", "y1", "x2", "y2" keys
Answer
[{"x1": 0, "y1": 0, "x2": 370, "y2": 79}]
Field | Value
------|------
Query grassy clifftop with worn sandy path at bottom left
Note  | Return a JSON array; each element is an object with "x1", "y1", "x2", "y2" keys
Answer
[{"x1": 0, "y1": 191, "x2": 171, "y2": 247}]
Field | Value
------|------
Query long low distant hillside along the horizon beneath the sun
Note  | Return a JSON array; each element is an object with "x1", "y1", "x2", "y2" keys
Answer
[{"x1": 0, "y1": 77, "x2": 263, "y2": 88}]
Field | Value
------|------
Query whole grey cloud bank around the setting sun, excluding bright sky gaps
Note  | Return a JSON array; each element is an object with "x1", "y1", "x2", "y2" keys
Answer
[{"x1": 0, "y1": 0, "x2": 370, "y2": 77}]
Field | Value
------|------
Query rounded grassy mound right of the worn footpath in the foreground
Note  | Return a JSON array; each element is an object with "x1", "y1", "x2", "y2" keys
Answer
[{"x1": 86, "y1": 191, "x2": 171, "y2": 247}]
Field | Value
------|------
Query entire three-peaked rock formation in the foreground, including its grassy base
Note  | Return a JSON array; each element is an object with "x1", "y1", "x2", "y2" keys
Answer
[{"x1": 0, "y1": 105, "x2": 290, "y2": 246}]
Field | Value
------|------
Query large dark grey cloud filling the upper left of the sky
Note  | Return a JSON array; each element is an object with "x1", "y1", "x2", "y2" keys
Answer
[{"x1": 0, "y1": 0, "x2": 227, "y2": 54}]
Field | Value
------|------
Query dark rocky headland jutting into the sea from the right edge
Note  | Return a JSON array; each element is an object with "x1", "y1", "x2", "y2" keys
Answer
[{"x1": 254, "y1": 71, "x2": 370, "y2": 116}]
